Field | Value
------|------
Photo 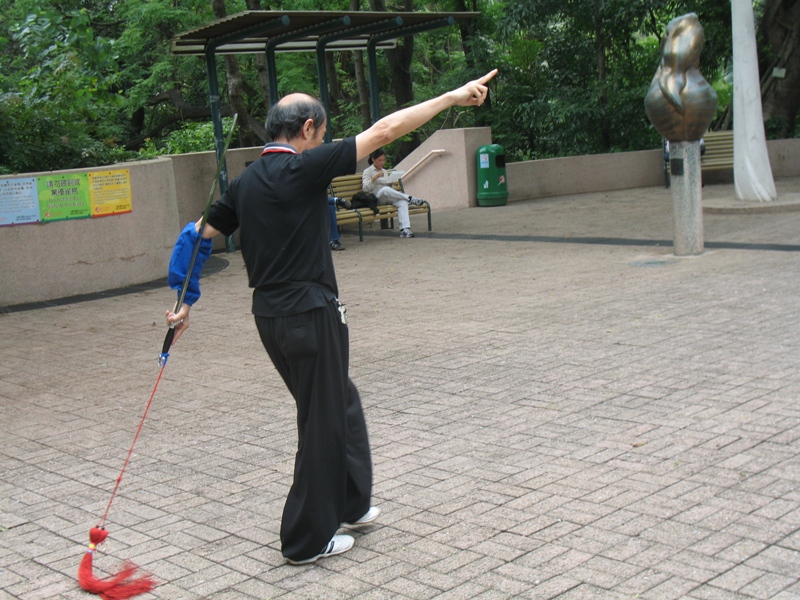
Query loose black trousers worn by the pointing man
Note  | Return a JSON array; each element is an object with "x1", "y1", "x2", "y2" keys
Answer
[{"x1": 256, "y1": 301, "x2": 372, "y2": 560}]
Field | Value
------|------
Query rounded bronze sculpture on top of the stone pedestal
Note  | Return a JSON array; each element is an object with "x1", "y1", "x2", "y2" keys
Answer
[{"x1": 644, "y1": 13, "x2": 717, "y2": 141}]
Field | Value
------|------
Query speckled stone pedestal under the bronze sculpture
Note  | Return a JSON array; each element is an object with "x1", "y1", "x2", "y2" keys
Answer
[{"x1": 669, "y1": 141, "x2": 704, "y2": 256}]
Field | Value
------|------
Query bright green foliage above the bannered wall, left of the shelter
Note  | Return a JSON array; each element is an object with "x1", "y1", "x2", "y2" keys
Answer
[{"x1": 0, "y1": 0, "x2": 216, "y2": 172}]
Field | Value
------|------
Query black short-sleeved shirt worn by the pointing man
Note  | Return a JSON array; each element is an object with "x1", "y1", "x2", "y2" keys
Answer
[{"x1": 208, "y1": 137, "x2": 356, "y2": 317}]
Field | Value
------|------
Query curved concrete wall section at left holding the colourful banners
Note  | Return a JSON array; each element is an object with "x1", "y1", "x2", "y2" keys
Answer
[{"x1": 0, "y1": 158, "x2": 178, "y2": 306}]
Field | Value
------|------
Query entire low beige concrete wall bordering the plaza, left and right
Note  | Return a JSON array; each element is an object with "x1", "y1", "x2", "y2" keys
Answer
[{"x1": 0, "y1": 134, "x2": 800, "y2": 307}]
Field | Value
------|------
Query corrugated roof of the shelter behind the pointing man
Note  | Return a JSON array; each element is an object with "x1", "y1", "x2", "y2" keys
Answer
[{"x1": 170, "y1": 10, "x2": 478, "y2": 56}]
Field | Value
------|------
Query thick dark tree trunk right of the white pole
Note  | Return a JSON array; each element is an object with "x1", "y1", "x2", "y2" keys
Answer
[{"x1": 760, "y1": 0, "x2": 800, "y2": 138}]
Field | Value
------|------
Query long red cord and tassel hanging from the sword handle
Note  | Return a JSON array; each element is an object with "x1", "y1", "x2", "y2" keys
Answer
[{"x1": 78, "y1": 360, "x2": 166, "y2": 600}]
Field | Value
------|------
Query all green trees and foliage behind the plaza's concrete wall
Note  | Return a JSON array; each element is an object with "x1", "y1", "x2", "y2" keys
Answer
[{"x1": 0, "y1": 0, "x2": 763, "y2": 172}]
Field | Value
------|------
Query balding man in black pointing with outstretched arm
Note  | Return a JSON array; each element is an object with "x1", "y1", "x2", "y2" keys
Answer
[{"x1": 167, "y1": 71, "x2": 496, "y2": 564}]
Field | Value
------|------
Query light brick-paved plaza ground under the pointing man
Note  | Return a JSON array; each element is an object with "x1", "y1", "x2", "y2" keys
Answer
[{"x1": 0, "y1": 179, "x2": 800, "y2": 600}]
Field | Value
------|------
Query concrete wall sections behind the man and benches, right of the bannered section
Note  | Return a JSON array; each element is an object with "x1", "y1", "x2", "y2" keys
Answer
[{"x1": 167, "y1": 136, "x2": 800, "y2": 220}]
